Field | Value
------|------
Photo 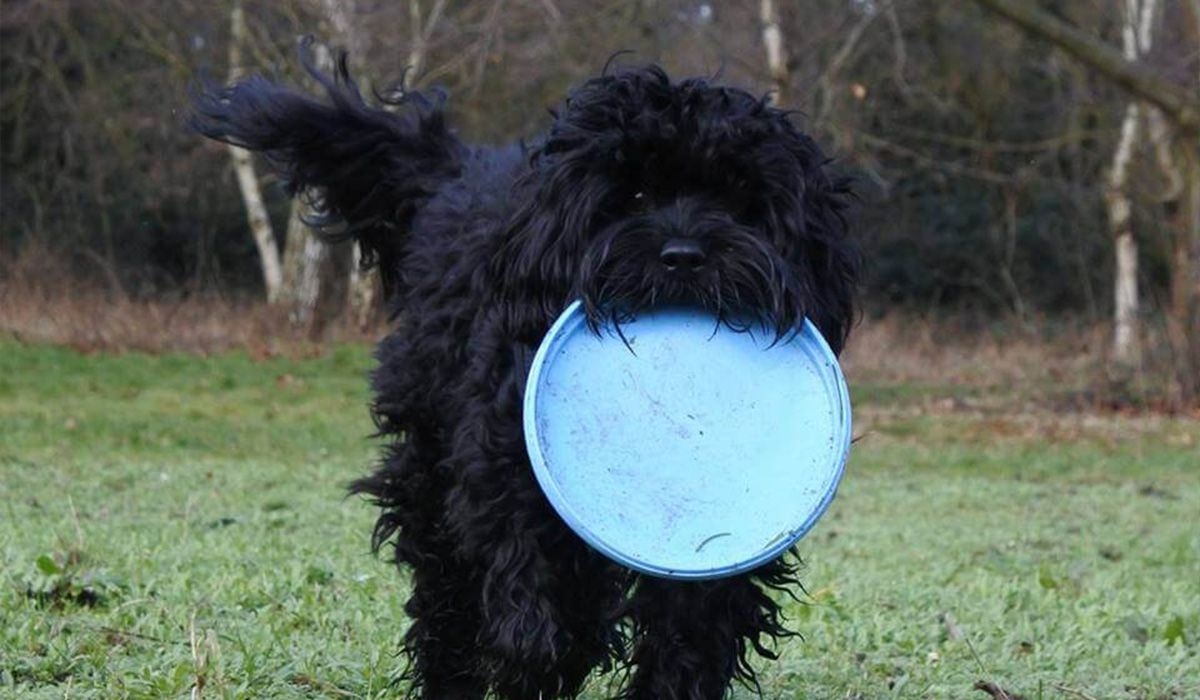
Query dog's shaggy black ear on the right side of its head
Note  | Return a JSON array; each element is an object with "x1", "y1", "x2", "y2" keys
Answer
[{"x1": 760, "y1": 121, "x2": 862, "y2": 353}]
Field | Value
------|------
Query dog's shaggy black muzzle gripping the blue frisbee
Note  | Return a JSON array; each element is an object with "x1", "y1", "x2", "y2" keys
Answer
[{"x1": 577, "y1": 221, "x2": 805, "y2": 341}]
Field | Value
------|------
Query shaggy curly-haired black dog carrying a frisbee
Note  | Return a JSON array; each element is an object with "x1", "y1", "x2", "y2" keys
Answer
[{"x1": 193, "y1": 50, "x2": 858, "y2": 700}]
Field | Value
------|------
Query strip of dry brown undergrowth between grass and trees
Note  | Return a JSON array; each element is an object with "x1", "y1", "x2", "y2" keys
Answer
[{"x1": 0, "y1": 246, "x2": 1185, "y2": 411}]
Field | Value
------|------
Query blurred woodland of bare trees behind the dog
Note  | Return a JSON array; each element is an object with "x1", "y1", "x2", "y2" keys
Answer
[{"x1": 0, "y1": 0, "x2": 1200, "y2": 409}]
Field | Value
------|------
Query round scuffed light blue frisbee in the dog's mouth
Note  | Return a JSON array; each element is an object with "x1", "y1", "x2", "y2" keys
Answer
[{"x1": 524, "y1": 301, "x2": 851, "y2": 579}]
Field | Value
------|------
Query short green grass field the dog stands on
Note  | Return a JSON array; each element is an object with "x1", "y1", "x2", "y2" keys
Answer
[{"x1": 0, "y1": 343, "x2": 1200, "y2": 699}]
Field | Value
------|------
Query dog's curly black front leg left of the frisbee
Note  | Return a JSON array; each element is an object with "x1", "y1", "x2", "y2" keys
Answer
[{"x1": 446, "y1": 319, "x2": 626, "y2": 700}]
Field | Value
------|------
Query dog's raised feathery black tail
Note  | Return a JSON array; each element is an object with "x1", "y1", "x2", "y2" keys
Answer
[{"x1": 191, "y1": 40, "x2": 466, "y2": 297}]
